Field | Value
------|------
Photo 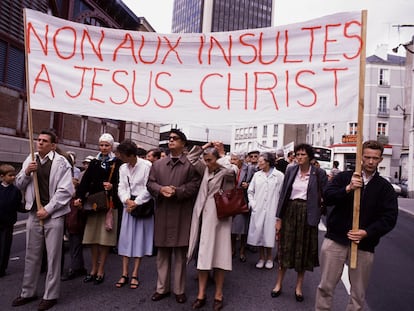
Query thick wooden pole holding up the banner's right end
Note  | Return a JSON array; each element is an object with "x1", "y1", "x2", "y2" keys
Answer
[{"x1": 350, "y1": 10, "x2": 367, "y2": 269}]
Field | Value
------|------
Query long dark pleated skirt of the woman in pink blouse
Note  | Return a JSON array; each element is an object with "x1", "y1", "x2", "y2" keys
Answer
[{"x1": 278, "y1": 200, "x2": 319, "y2": 272}]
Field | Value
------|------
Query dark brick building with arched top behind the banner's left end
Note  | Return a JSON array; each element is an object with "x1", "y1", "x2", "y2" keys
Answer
[{"x1": 0, "y1": 0, "x2": 159, "y2": 165}]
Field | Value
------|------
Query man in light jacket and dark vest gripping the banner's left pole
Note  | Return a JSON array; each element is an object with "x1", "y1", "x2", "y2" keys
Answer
[{"x1": 12, "y1": 130, "x2": 74, "y2": 310}]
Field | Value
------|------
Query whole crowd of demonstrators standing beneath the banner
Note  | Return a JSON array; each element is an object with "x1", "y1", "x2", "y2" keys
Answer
[{"x1": 0, "y1": 129, "x2": 398, "y2": 310}]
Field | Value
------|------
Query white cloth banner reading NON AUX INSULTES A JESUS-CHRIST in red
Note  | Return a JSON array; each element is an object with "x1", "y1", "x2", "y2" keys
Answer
[{"x1": 25, "y1": 9, "x2": 362, "y2": 125}]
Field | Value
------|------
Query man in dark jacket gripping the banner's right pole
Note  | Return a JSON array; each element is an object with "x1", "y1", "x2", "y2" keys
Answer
[{"x1": 315, "y1": 140, "x2": 398, "y2": 311}]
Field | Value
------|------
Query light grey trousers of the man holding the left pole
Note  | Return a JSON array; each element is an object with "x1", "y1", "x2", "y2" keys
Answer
[{"x1": 21, "y1": 212, "x2": 64, "y2": 299}]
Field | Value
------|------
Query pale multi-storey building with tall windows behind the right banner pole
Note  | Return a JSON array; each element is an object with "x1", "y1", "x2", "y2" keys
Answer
[{"x1": 307, "y1": 55, "x2": 409, "y2": 180}]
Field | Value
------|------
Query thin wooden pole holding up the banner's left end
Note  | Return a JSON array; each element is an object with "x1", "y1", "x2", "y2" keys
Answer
[{"x1": 23, "y1": 9, "x2": 43, "y2": 226}]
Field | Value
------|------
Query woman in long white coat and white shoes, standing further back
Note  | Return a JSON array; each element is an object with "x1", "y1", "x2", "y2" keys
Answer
[{"x1": 247, "y1": 152, "x2": 284, "y2": 269}]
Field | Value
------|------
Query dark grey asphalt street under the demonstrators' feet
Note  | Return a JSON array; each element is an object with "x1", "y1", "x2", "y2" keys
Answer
[{"x1": 0, "y1": 199, "x2": 414, "y2": 311}]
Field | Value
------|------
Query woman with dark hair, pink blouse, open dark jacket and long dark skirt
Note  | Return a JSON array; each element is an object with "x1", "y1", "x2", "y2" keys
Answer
[{"x1": 271, "y1": 144, "x2": 327, "y2": 302}]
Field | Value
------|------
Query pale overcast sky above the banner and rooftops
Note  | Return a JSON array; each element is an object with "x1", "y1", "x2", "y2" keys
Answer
[{"x1": 123, "y1": 0, "x2": 414, "y2": 56}]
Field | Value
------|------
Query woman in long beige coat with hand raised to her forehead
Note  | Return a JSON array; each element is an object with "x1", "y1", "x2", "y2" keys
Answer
[{"x1": 188, "y1": 143, "x2": 237, "y2": 310}]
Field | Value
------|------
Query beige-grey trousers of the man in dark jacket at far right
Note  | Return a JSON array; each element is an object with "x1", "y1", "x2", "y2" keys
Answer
[{"x1": 315, "y1": 238, "x2": 374, "y2": 311}]
